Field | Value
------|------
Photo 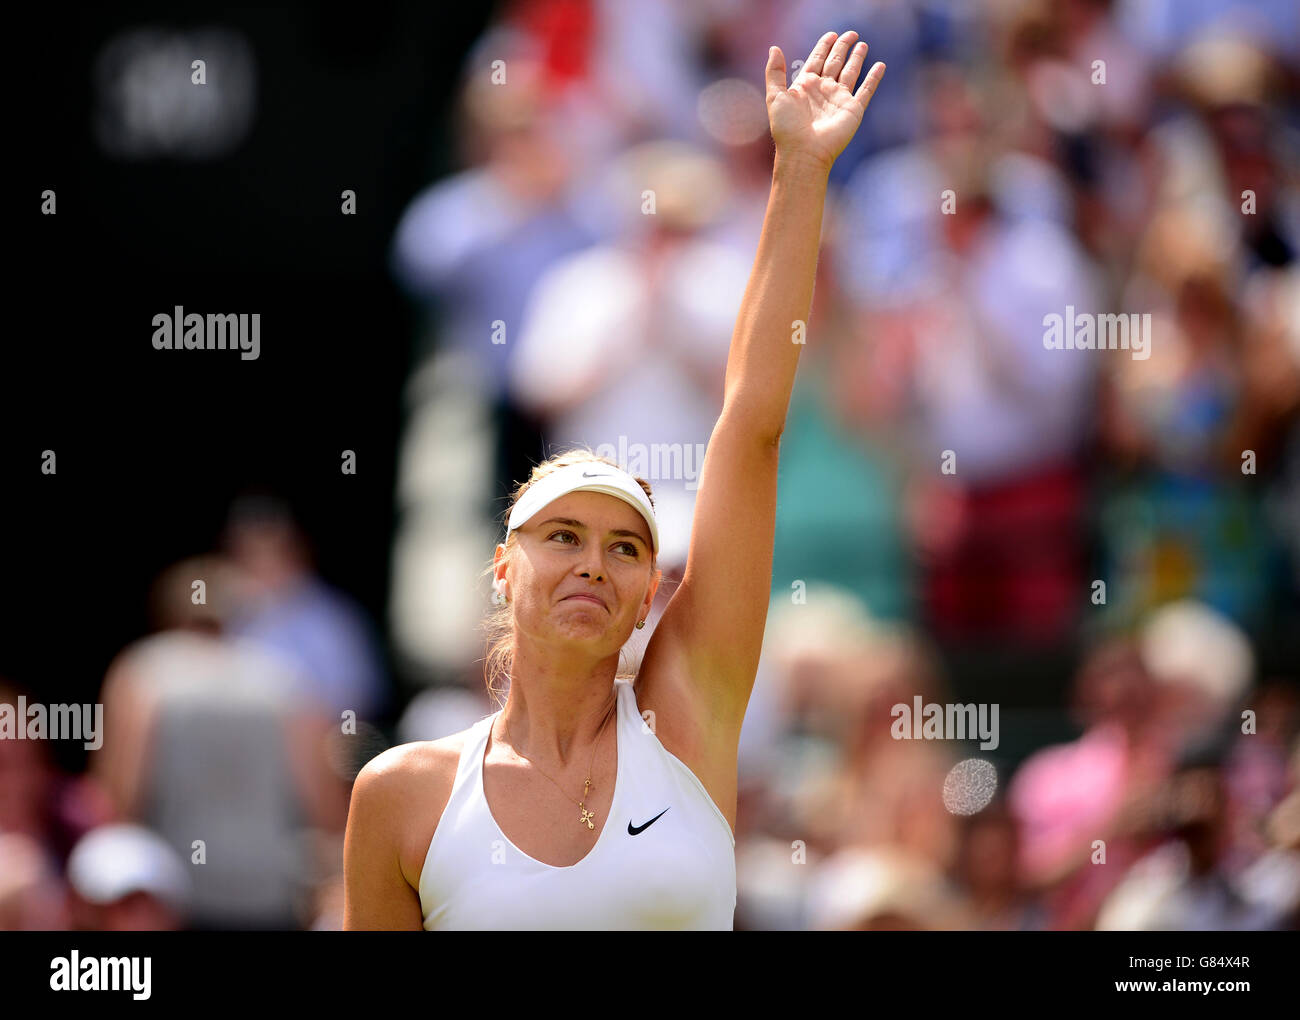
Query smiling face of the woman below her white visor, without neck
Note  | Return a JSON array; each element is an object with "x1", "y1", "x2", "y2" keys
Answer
[{"x1": 497, "y1": 492, "x2": 660, "y2": 655}]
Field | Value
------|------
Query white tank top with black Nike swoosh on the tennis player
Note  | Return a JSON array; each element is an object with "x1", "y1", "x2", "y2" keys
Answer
[{"x1": 420, "y1": 680, "x2": 736, "y2": 932}]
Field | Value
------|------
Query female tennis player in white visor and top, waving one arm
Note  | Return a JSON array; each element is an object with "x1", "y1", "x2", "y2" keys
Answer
[{"x1": 343, "y1": 31, "x2": 885, "y2": 930}]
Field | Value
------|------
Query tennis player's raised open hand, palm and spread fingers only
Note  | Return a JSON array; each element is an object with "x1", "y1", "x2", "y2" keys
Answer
[{"x1": 767, "y1": 31, "x2": 885, "y2": 170}]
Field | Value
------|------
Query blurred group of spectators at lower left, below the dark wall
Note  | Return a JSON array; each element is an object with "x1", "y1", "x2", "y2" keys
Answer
[{"x1": 0, "y1": 494, "x2": 391, "y2": 930}]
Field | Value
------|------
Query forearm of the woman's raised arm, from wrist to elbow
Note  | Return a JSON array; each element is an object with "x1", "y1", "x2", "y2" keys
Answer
[{"x1": 723, "y1": 151, "x2": 831, "y2": 443}]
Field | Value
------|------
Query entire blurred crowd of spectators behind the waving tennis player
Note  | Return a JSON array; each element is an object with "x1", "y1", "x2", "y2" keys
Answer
[{"x1": 0, "y1": 0, "x2": 1300, "y2": 929}]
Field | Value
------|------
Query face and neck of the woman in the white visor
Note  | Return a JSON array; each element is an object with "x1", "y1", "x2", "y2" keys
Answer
[{"x1": 495, "y1": 492, "x2": 663, "y2": 761}]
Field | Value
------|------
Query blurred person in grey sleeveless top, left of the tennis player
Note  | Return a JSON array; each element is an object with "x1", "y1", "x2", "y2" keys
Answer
[{"x1": 91, "y1": 556, "x2": 347, "y2": 928}]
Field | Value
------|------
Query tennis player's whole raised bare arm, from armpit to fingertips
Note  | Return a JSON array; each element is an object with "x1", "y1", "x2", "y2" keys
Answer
[{"x1": 642, "y1": 31, "x2": 885, "y2": 733}]
